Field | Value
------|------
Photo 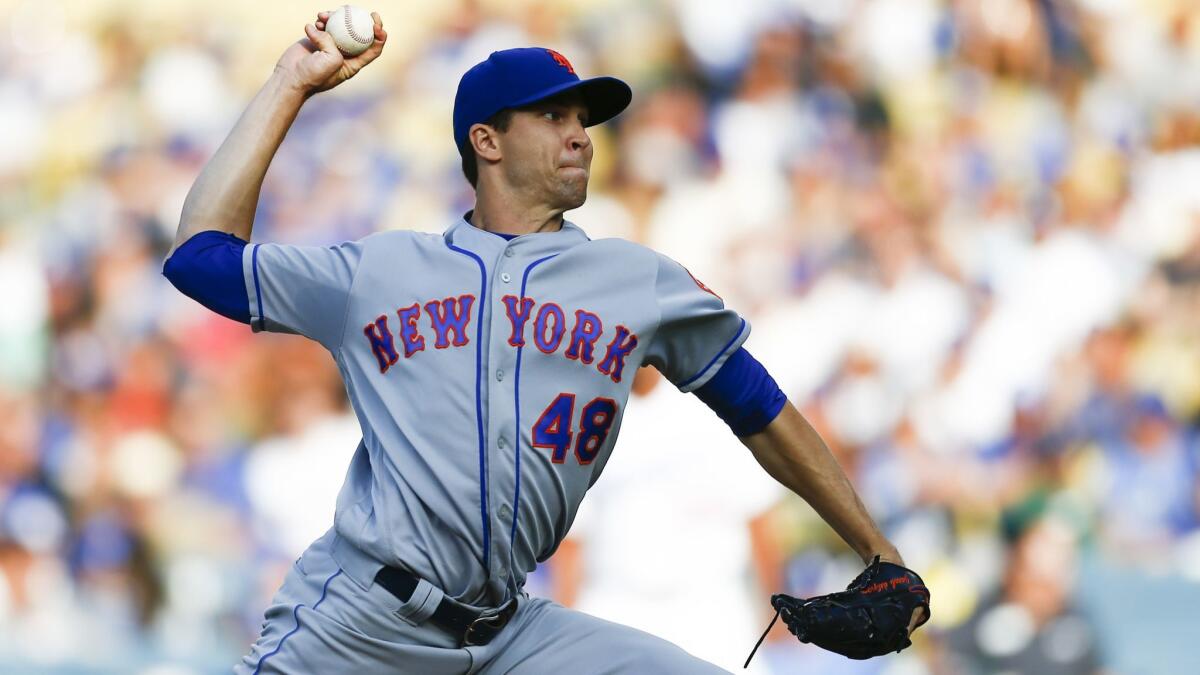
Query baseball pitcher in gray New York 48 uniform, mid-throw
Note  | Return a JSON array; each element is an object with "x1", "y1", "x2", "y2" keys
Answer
[{"x1": 163, "y1": 12, "x2": 928, "y2": 674}]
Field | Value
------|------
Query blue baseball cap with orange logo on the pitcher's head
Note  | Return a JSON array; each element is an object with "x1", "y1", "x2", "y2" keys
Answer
[{"x1": 454, "y1": 47, "x2": 634, "y2": 154}]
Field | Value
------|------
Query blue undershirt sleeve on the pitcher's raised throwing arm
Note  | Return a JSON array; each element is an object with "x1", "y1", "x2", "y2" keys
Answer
[{"x1": 162, "y1": 229, "x2": 250, "y2": 323}]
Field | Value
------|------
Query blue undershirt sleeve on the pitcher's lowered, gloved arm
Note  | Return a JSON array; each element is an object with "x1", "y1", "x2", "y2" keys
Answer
[{"x1": 694, "y1": 347, "x2": 787, "y2": 436}]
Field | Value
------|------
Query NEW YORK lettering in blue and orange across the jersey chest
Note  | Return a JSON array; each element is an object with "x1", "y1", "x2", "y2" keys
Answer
[{"x1": 362, "y1": 294, "x2": 637, "y2": 382}]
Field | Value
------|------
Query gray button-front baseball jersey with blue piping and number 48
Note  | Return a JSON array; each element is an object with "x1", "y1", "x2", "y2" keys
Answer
[{"x1": 242, "y1": 214, "x2": 750, "y2": 607}]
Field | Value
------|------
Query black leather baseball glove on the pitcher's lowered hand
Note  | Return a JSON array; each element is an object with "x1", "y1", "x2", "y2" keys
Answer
[{"x1": 746, "y1": 556, "x2": 929, "y2": 665}]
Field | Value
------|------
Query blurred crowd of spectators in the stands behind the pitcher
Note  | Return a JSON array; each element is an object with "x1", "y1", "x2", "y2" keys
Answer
[{"x1": 0, "y1": 0, "x2": 1200, "y2": 674}]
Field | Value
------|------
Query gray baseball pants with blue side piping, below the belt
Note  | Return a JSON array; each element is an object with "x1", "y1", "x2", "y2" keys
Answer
[{"x1": 234, "y1": 528, "x2": 726, "y2": 675}]
